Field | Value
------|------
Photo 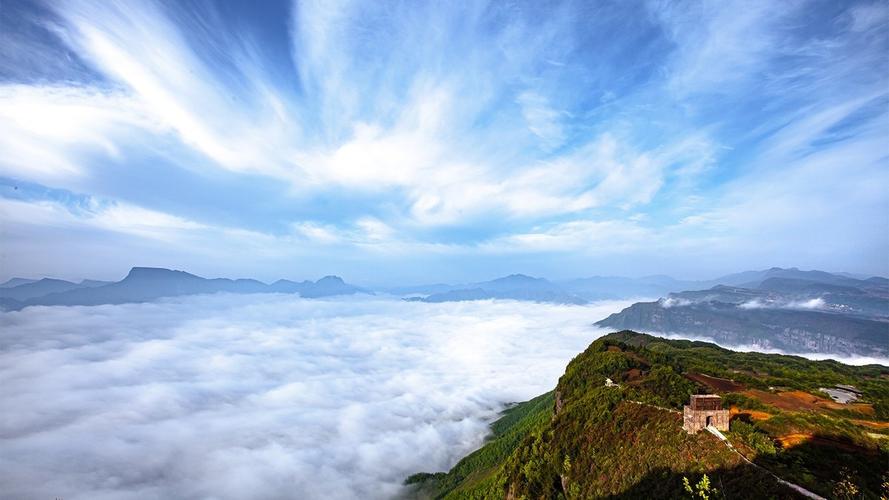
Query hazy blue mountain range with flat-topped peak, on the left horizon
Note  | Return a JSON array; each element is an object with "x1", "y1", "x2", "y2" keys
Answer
[{"x1": 0, "y1": 267, "x2": 365, "y2": 310}]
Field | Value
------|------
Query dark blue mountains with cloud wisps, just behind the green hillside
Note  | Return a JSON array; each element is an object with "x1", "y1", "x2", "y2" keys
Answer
[{"x1": 596, "y1": 268, "x2": 889, "y2": 356}]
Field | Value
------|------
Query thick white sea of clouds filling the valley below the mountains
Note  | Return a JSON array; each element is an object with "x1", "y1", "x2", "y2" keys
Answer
[{"x1": 0, "y1": 295, "x2": 629, "y2": 500}]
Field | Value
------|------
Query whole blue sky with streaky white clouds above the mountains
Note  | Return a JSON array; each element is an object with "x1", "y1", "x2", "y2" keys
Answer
[{"x1": 0, "y1": 0, "x2": 889, "y2": 284}]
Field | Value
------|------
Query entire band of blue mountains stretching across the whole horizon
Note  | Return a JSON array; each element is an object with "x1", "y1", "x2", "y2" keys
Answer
[{"x1": 6, "y1": 267, "x2": 889, "y2": 353}]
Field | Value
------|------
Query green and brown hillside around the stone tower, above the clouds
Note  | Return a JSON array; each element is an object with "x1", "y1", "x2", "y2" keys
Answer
[{"x1": 406, "y1": 331, "x2": 889, "y2": 499}]
